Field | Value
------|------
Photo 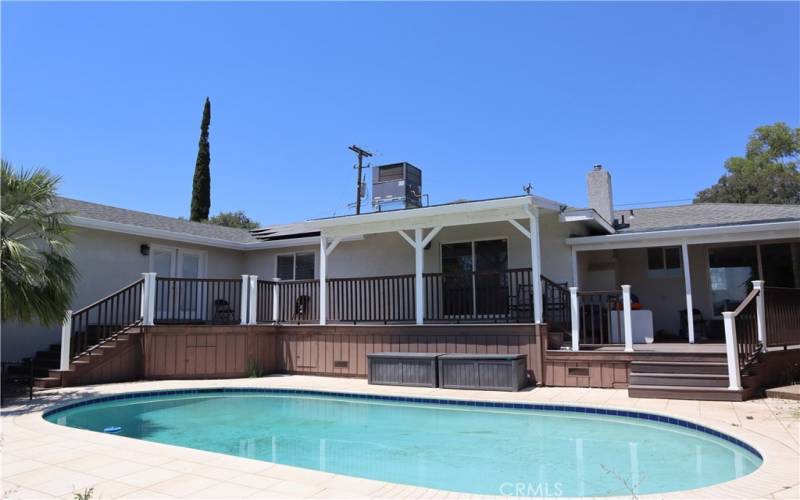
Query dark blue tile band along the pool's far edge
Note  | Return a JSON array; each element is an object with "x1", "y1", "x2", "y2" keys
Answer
[{"x1": 42, "y1": 387, "x2": 764, "y2": 460}]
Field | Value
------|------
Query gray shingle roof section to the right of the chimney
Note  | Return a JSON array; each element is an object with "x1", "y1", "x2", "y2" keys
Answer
[{"x1": 614, "y1": 203, "x2": 800, "y2": 233}]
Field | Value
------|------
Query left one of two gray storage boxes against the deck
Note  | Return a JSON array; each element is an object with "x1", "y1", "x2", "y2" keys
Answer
[{"x1": 367, "y1": 352, "x2": 442, "y2": 387}]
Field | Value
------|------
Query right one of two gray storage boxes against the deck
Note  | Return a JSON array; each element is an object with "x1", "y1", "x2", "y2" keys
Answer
[{"x1": 438, "y1": 354, "x2": 528, "y2": 391}]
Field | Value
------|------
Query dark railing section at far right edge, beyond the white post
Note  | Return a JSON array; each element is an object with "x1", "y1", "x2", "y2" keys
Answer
[{"x1": 764, "y1": 286, "x2": 800, "y2": 347}]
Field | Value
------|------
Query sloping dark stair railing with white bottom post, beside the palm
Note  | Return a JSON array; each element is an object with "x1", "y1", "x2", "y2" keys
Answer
[{"x1": 67, "y1": 280, "x2": 144, "y2": 362}]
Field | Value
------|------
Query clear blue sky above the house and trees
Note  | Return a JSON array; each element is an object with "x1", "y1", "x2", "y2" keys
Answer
[{"x1": 2, "y1": 2, "x2": 800, "y2": 223}]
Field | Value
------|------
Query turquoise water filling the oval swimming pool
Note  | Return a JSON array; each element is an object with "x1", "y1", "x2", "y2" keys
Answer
[{"x1": 45, "y1": 391, "x2": 761, "y2": 496}]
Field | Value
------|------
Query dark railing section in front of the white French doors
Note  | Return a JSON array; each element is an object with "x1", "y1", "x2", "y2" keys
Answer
[{"x1": 153, "y1": 277, "x2": 246, "y2": 324}]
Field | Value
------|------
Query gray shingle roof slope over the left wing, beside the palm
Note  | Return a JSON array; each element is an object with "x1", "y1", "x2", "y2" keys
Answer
[{"x1": 56, "y1": 197, "x2": 258, "y2": 243}]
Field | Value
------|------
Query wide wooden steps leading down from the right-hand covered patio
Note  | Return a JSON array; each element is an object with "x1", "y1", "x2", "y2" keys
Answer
[{"x1": 628, "y1": 353, "x2": 758, "y2": 401}]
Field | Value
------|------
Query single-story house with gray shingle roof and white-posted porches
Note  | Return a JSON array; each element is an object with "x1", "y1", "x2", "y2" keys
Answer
[{"x1": 2, "y1": 164, "x2": 800, "y2": 400}]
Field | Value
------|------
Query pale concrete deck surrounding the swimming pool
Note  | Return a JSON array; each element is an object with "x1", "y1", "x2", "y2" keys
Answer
[{"x1": 1, "y1": 375, "x2": 800, "y2": 499}]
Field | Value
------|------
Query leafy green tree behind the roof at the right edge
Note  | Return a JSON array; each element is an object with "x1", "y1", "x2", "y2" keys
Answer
[{"x1": 694, "y1": 122, "x2": 800, "y2": 204}]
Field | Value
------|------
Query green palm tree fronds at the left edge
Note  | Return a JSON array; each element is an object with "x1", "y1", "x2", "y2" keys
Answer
[{"x1": 0, "y1": 160, "x2": 77, "y2": 325}]
